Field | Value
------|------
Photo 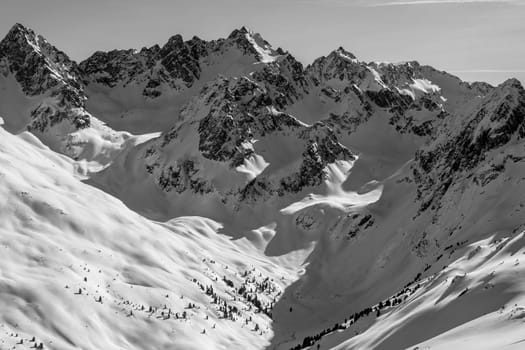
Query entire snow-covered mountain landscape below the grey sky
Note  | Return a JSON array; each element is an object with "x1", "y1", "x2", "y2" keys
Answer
[{"x1": 0, "y1": 25, "x2": 525, "y2": 349}]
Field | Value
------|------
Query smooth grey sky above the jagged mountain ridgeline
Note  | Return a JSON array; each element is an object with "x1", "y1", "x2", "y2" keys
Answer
[{"x1": 0, "y1": 0, "x2": 525, "y2": 84}]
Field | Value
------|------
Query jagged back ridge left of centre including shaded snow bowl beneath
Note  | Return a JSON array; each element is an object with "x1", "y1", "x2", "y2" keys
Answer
[{"x1": 79, "y1": 27, "x2": 302, "y2": 133}]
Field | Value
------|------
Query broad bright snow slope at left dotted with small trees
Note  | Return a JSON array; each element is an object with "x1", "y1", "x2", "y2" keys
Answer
[{"x1": 0, "y1": 124, "x2": 312, "y2": 349}]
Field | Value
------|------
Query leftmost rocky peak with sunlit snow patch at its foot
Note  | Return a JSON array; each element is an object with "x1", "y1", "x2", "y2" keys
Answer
[{"x1": 0, "y1": 24, "x2": 130, "y2": 169}]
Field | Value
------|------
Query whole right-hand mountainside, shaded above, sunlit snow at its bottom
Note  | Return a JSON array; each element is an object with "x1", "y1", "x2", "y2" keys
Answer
[{"x1": 274, "y1": 81, "x2": 524, "y2": 349}]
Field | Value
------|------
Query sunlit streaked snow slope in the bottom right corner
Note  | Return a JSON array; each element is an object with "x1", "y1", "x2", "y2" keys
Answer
[{"x1": 294, "y1": 227, "x2": 525, "y2": 350}]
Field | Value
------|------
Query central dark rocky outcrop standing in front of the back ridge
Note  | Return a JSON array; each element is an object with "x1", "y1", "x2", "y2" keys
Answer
[{"x1": 141, "y1": 77, "x2": 354, "y2": 201}]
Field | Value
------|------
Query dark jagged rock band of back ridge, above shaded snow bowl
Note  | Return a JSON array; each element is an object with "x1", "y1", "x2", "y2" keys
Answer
[{"x1": 80, "y1": 27, "x2": 286, "y2": 99}]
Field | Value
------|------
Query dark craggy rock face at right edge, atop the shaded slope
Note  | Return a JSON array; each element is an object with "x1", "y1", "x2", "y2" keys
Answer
[{"x1": 414, "y1": 79, "x2": 525, "y2": 210}]
